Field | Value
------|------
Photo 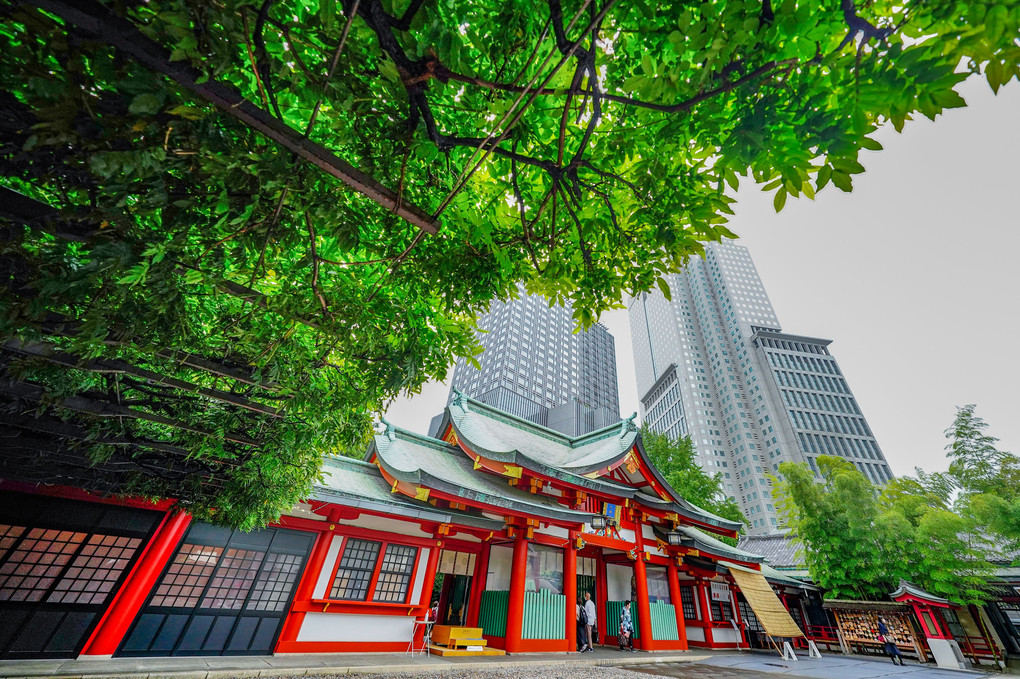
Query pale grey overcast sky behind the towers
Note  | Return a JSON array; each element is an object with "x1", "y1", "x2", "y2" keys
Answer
[{"x1": 387, "y1": 79, "x2": 1020, "y2": 475}]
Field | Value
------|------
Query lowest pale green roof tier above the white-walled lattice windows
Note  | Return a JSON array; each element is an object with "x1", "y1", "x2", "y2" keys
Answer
[{"x1": 313, "y1": 458, "x2": 503, "y2": 530}]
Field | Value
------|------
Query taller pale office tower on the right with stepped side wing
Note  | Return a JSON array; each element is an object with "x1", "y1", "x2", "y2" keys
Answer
[{"x1": 628, "y1": 242, "x2": 893, "y2": 534}]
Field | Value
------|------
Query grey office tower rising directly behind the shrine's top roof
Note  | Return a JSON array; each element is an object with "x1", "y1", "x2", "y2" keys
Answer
[{"x1": 438, "y1": 292, "x2": 620, "y2": 436}]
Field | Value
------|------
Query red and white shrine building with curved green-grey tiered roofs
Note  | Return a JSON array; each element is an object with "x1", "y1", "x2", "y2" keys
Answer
[{"x1": 0, "y1": 396, "x2": 803, "y2": 659}]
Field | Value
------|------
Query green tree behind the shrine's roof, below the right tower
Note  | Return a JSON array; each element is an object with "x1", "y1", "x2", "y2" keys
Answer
[{"x1": 641, "y1": 427, "x2": 745, "y2": 523}]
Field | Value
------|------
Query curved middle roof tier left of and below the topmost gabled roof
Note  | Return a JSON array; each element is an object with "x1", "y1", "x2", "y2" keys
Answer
[{"x1": 365, "y1": 426, "x2": 592, "y2": 523}]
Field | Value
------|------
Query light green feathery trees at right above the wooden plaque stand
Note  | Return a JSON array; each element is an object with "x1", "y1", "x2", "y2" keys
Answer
[{"x1": 776, "y1": 428, "x2": 995, "y2": 605}]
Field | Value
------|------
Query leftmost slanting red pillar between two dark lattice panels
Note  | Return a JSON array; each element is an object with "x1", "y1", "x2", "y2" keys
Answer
[{"x1": 82, "y1": 512, "x2": 191, "y2": 656}]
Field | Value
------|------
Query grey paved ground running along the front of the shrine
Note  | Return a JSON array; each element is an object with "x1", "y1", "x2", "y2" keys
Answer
[{"x1": 0, "y1": 648, "x2": 990, "y2": 679}]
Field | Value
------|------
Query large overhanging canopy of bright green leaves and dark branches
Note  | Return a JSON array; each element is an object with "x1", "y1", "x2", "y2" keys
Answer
[{"x1": 0, "y1": 0, "x2": 1020, "y2": 526}]
